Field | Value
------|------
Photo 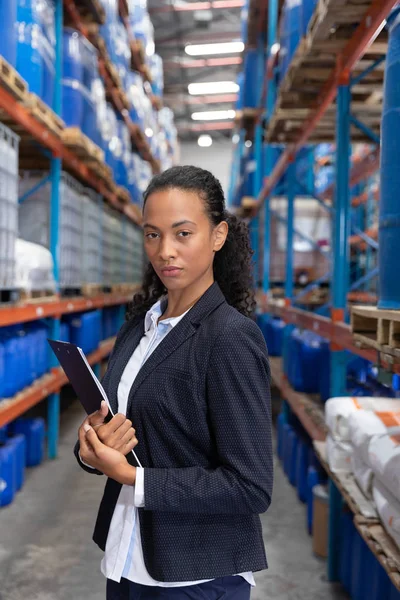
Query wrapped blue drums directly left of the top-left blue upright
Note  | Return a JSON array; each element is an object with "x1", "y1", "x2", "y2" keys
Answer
[{"x1": 15, "y1": 0, "x2": 56, "y2": 106}]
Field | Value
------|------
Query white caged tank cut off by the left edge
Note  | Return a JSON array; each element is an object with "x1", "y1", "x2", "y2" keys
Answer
[{"x1": 0, "y1": 124, "x2": 19, "y2": 290}]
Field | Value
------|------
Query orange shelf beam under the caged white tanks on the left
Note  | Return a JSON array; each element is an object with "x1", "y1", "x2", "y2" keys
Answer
[{"x1": 0, "y1": 294, "x2": 132, "y2": 327}]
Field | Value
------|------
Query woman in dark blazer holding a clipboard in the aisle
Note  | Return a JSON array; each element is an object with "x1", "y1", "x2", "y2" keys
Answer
[{"x1": 75, "y1": 166, "x2": 273, "y2": 600}]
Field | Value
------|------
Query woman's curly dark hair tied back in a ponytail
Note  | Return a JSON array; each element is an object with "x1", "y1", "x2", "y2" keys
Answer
[{"x1": 127, "y1": 166, "x2": 256, "y2": 320}]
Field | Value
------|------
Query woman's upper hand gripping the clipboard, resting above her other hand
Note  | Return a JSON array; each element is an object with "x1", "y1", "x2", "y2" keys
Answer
[{"x1": 79, "y1": 400, "x2": 138, "y2": 464}]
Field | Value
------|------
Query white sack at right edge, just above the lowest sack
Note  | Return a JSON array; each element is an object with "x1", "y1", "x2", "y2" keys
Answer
[{"x1": 368, "y1": 427, "x2": 400, "y2": 498}]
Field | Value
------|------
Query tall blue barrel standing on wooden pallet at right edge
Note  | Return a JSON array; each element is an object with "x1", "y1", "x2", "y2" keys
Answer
[{"x1": 378, "y1": 8, "x2": 400, "y2": 310}]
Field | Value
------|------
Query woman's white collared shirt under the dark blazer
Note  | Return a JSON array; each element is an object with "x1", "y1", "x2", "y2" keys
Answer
[{"x1": 101, "y1": 298, "x2": 255, "y2": 587}]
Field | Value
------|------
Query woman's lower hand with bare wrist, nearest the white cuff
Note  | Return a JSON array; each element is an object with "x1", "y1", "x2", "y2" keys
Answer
[{"x1": 79, "y1": 423, "x2": 136, "y2": 485}]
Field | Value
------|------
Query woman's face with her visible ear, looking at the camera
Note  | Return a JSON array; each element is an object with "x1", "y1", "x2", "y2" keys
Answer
[{"x1": 143, "y1": 188, "x2": 228, "y2": 290}]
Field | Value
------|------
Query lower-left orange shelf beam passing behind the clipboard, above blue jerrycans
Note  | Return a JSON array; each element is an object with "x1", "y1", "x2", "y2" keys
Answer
[{"x1": 0, "y1": 338, "x2": 115, "y2": 427}]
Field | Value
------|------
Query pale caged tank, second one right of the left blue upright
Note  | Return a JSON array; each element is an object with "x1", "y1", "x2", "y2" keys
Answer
[{"x1": 82, "y1": 189, "x2": 102, "y2": 284}]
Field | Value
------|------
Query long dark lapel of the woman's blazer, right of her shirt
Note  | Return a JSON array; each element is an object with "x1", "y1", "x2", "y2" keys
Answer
[{"x1": 126, "y1": 282, "x2": 226, "y2": 414}]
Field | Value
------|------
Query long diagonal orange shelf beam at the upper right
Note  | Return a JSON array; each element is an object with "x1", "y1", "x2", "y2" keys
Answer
[{"x1": 255, "y1": 0, "x2": 397, "y2": 212}]
